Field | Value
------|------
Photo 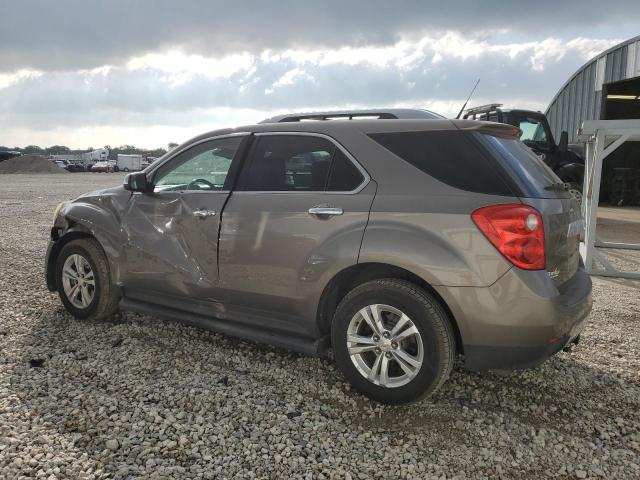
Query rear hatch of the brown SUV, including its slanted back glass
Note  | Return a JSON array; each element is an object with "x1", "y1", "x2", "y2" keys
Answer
[{"x1": 473, "y1": 128, "x2": 583, "y2": 286}]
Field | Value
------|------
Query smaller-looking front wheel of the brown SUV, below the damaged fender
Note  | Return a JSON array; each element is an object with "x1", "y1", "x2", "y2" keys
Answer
[{"x1": 55, "y1": 238, "x2": 119, "y2": 320}]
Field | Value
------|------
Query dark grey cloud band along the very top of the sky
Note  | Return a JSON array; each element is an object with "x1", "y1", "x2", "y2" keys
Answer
[{"x1": 0, "y1": 0, "x2": 640, "y2": 72}]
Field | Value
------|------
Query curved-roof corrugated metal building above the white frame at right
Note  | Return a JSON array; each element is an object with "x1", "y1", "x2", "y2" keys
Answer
[{"x1": 546, "y1": 35, "x2": 640, "y2": 143}]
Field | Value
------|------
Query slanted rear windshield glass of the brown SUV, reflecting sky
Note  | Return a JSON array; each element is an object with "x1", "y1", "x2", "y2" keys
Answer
[{"x1": 475, "y1": 133, "x2": 570, "y2": 198}]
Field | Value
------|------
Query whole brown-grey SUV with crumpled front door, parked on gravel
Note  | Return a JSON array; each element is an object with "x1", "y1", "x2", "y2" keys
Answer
[{"x1": 46, "y1": 110, "x2": 591, "y2": 403}]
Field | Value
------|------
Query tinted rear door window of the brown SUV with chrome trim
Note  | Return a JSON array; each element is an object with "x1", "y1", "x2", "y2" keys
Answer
[{"x1": 240, "y1": 135, "x2": 364, "y2": 192}]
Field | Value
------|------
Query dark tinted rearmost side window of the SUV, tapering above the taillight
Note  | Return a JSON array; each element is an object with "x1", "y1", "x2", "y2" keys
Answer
[{"x1": 369, "y1": 131, "x2": 513, "y2": 196}]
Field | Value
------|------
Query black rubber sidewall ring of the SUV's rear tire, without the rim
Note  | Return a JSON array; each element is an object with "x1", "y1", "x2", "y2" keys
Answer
[{"x1": 332, "y1": 285, "x2": 445, "y2": 403}]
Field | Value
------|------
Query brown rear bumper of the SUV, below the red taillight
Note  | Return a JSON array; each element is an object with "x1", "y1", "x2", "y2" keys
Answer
[{"x1": 437, "y1": 268, "x2": 592, "y2": 370}]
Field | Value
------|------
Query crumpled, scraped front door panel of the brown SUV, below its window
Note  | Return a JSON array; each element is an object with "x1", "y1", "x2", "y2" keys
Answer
[{"x1": 123, "y1": 192, "x2": 227, "y2": 299}]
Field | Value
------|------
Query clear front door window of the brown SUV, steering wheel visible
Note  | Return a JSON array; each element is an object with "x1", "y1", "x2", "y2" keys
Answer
[{"x1": 154, "y1": 137, "x2": 244, "y2": 192}]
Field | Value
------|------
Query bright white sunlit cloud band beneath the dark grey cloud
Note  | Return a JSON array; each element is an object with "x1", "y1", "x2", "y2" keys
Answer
[{"x1": 0, "y1": 40, "x2": 596, "y2": 128}]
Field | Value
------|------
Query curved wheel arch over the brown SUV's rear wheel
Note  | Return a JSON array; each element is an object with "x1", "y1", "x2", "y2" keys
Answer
[{"x1": 316, "y1": 262, "x2": 463, "y2": 353}]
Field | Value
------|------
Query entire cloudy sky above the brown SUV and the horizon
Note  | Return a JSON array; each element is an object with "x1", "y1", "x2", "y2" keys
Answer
[{"x1": 0, "y1": 0, "x2": 640, "y2": 148}]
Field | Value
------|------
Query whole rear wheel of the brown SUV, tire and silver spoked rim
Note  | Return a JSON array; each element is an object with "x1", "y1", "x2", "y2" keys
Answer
[{"x1": 331, "y1": 279, "x2": 455, "y2": 404}]
